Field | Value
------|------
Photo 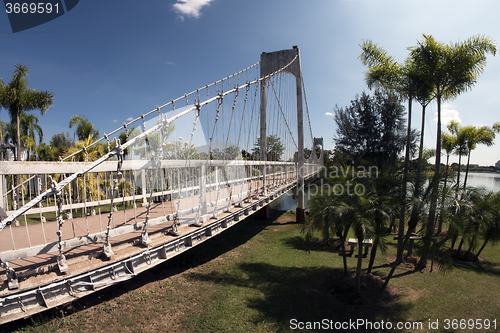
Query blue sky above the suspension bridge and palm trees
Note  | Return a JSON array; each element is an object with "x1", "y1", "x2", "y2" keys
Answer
[{"x1": 0, "y1": 0, "x2": 500, "y2": 165}]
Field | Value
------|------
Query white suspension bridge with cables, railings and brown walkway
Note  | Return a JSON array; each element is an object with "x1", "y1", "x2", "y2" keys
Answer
[{"x1": 0, "y1": 47, "x2": 323, "y2": 323}]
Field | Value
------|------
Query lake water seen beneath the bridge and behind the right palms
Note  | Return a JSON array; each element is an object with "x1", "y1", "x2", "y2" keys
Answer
[{"x1": 269, "y1": 172, "x2": 500, "y2": 210}]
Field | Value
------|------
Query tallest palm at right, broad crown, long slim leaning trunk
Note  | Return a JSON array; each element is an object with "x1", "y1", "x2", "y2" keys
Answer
[{"x1": 412, "y1": 35, "x2": 496, "y2": 267}]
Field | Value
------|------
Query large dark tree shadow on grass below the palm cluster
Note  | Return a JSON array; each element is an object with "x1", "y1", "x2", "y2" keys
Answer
[{"x1": 190, "y1": 263, "x2": 412, "y2": 332}]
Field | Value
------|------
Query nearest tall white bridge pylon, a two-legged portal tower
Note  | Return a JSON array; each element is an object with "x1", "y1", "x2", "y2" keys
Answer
[{"x1": 260, "y1": 46, "x2": 305, "y2": 222}]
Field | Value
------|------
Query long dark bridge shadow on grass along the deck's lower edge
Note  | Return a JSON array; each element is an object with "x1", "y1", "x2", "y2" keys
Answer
[{"x1": 2, "y1": 210, "x2": 285, "y2": 332}]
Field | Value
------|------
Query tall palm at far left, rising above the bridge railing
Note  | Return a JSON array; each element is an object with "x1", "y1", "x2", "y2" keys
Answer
[{"x1": 0, "y1": 64, "x2": 54, "y2": 161}]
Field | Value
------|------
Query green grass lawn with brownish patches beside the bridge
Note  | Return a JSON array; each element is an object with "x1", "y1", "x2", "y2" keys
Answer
[{"x1": 0, "y1": 211, "x2": 500, "y2": 332}]
